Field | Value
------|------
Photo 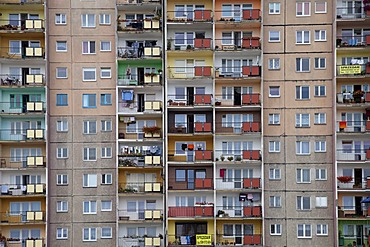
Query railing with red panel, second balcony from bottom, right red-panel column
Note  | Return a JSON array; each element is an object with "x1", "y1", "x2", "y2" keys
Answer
[{"x1": 216, "y1": 206, "x2": 262, "y2": 218}]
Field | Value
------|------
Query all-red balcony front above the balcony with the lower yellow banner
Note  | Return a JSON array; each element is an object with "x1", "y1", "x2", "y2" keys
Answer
[{"x1": 168, "y1": 205, "x2": 214, "y2": 218}]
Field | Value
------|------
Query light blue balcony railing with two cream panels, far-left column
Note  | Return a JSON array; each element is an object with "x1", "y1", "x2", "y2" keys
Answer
[{"x1": 0, "y1": 129, "x2": 45, "y2": 141}]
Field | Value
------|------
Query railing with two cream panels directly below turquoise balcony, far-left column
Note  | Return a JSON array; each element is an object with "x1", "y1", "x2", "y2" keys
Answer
[{"x1": 0, "y1": 155, "x2": 46, "y2": 168}]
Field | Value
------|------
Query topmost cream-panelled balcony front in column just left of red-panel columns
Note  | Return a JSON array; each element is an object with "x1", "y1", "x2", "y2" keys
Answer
[{"x1": 117, "y1": 19, "x2": 162, "y2": 32}]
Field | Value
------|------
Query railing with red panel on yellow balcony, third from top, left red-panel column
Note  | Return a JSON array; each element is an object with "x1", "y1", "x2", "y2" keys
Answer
[{"x1": 168, "y1": 66, "x2": 213, "y2": 79}]
